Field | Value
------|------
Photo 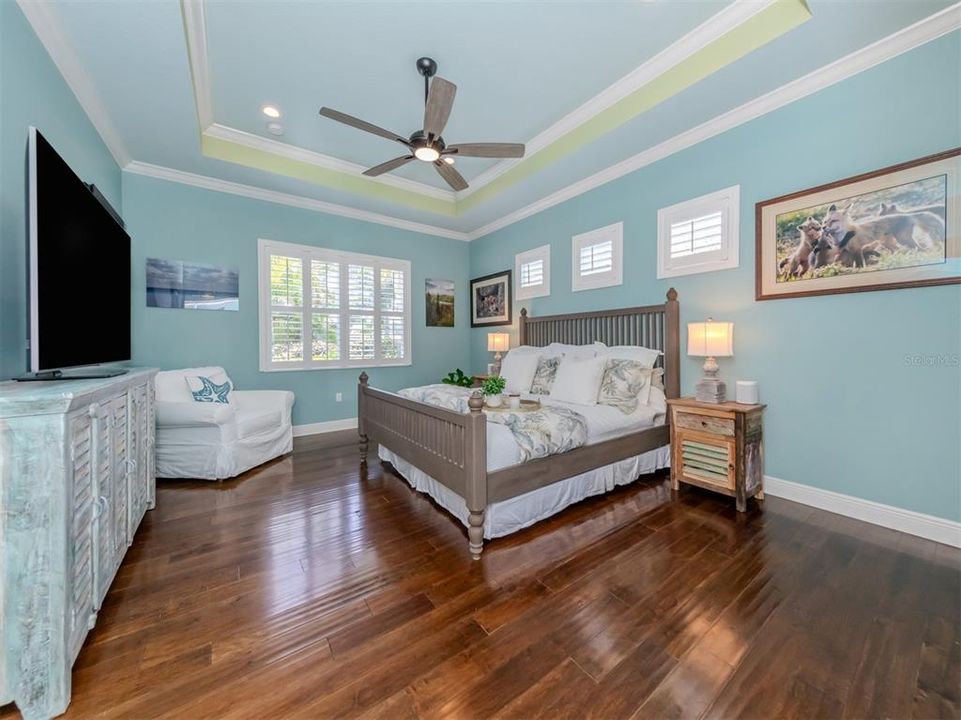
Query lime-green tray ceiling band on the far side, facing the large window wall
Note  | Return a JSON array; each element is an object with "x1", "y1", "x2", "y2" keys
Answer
[{"x1": 200, "y1": 134, "x2": 457, "y2": 216}]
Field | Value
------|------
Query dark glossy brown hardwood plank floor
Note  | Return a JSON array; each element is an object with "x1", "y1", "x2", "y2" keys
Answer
[{"x1": 0, "y1": 442, "x2": 961, "y2": 720}]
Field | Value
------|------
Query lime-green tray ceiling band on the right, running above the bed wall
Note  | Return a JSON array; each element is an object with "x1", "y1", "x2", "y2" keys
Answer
[{"x1": 457, "y1": 0, "x2": 811, "y2": 215}]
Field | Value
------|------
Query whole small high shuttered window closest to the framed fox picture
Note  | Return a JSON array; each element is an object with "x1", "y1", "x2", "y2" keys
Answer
[{"x1": 657, "y1": 185, "x2": 740, "y2": 278}]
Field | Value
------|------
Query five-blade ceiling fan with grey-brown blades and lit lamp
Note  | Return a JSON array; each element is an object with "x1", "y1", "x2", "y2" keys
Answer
[{"x1": 320, "y1": 57, "x2": 524, "y2": 190}]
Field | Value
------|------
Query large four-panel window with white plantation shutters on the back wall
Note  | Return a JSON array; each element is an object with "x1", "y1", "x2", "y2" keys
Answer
[{"x1": 259, "y1": 240, "x2": 411, "y2": 371}]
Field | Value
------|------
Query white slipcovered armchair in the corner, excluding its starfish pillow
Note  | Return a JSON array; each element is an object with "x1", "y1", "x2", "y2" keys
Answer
[{"x1": 155, "y1": 367, "x2": 294, "y2": 480}]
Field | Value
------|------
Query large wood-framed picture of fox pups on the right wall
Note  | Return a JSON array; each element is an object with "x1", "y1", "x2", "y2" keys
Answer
[{"x1": 755, "y1": 148, "x2": 961, "y2": 300}]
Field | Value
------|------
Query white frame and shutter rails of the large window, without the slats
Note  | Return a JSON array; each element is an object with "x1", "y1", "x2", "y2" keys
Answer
[{"x1": 257, "y1": 238, "x2": 414, "y2": 372}]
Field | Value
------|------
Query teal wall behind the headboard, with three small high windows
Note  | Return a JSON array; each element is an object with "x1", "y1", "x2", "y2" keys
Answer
[{"x1": 471, "y1": 32, "x2": 961, "y2": 520}]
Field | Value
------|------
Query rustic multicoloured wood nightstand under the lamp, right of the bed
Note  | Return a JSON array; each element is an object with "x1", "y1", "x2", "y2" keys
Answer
[{"x1": 667, "y1": 398, "x2": 765, "y2": 512}]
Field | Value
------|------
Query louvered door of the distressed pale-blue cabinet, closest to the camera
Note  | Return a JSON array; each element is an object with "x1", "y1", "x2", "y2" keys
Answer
[{"x1": 67, "y1": 408, "x2": 96, "y2": 661}]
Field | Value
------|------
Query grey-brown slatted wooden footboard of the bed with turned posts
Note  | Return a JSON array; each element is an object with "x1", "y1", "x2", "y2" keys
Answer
[{"x1": 357, "y1": 373, "x2": 487, "y2": 560}]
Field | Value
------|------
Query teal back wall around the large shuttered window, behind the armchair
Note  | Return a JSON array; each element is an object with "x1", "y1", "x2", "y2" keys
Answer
[{"x1": 123, "y1": 173, "x2": 470, "y2": 424}]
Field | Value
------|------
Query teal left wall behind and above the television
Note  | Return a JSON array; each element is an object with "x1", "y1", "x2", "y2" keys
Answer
[{"x1": 0, "y1": 0, "x2": 121, "y2": 379}]
